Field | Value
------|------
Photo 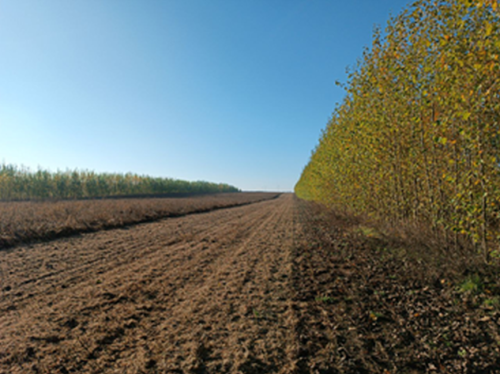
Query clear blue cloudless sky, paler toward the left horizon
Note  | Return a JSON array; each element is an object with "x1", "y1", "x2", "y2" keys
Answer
[{"x1": 0, "y1": 0, "x2": 411, "y2": 191}]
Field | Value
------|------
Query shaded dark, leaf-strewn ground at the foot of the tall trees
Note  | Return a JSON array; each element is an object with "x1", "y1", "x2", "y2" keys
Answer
[{"x1": 292, "y1": 202, "x2": 500, "y2": 374}]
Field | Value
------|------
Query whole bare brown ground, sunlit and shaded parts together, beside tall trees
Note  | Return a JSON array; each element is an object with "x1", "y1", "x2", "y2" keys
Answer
[{"x1": 0, "y1": 194, "x2": 500, "y2": 374}]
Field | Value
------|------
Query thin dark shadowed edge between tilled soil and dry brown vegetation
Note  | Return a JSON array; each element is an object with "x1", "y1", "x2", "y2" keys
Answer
[{"x1": 0, "y1": 193, "x2": 281, "y2": 251}]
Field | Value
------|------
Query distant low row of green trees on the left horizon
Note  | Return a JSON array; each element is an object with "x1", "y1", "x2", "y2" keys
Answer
[{"x1": 0, "y1": 164, "x2": 239, "y2": 201}]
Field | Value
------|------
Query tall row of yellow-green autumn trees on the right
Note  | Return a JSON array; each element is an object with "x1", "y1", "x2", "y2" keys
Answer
[{"x1": 295, "y1": 0, "x2": 500, "y2": 260}]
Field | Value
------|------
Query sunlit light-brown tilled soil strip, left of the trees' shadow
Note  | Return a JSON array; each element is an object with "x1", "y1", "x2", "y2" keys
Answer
[{"x1": 0, "y1": 194, "x2": 298, "y2": 373}]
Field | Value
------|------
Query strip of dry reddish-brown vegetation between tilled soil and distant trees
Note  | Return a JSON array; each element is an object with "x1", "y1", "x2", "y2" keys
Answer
[{"x1": 0, "y1": 192, "x2": 280, "y2": 249}]
